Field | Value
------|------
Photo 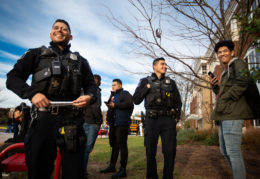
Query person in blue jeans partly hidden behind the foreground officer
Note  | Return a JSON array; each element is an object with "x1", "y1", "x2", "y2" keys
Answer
[{"x1": 83, "y1": 74, "x2": 103, "y2": 178}]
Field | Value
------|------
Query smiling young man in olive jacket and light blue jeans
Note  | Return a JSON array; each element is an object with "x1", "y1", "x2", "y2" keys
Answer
[{"x1": 211, "y1": 40, "x2": 253, "y2": 179}]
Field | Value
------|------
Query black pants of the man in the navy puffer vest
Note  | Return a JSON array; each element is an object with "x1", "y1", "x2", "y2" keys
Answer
[{"x1": 109, "y1": 126, "x2": 129, "y2": 168}]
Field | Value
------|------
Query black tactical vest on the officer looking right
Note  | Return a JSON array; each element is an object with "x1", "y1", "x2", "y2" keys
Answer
[{"x1": 145, "y1": 76, "x2": 174, "y2": 110}]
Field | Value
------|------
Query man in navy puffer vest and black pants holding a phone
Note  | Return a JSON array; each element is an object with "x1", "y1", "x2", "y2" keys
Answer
[{"x1": 100, "y1": 79, "x2": 134, "y2": 178}]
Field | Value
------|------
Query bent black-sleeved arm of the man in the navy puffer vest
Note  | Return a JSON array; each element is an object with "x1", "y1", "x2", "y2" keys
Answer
[{"x1": 114, "y1": 91, "x2": 133, "y2": 109}]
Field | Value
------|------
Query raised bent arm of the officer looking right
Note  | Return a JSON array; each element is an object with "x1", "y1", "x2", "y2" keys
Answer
[{"x1": 133, "y1": 78, "x2": 149, "y2": 105}]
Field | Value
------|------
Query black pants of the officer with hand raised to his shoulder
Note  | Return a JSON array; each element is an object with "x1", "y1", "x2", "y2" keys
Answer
[{"x1": 144, "y1": 116, "x2": 176, "y2": 179}]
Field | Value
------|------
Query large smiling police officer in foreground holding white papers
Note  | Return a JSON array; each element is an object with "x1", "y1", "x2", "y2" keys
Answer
[{"x1": 6, "y1": 19, "x2": 96, "y2": 179}]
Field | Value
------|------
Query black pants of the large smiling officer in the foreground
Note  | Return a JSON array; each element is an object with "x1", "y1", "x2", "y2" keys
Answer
[{"x1": 25, "y1": 112, "x2": 84, "y2": 179}]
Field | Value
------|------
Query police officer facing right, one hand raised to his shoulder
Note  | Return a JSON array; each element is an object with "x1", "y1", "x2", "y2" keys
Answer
[{"x1": 133, "y1": 58, "x2": 182, "y2": 178}]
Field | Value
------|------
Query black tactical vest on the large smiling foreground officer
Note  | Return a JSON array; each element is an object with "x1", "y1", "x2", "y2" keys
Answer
[{"x1": 32, "y1": 46, "x2": 82, "y2": 100}]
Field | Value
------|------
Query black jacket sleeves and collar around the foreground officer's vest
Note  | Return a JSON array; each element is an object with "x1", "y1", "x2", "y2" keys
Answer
[{"x1": 6, "y1": 42, "x2": 96, "y2": 100}]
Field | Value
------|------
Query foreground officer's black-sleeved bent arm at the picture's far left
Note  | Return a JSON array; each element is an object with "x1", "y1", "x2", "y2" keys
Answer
[{"x1": 6, "y1": 48, "x2": 41, "y2": 100}]
